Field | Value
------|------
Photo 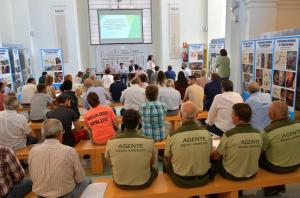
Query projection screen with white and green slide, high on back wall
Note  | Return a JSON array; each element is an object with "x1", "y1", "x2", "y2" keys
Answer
[{"x1": 98, "y1": 9, "x2": 144, "y2": 44}]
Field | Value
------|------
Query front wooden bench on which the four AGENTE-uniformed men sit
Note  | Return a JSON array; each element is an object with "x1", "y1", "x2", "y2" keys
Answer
[{"x1": 94, "y1": 169, "x2": 300, "y2": 198}]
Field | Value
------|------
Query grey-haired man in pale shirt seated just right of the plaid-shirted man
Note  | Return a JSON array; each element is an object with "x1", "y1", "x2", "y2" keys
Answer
[{"x1": 158, "y1": 79, "x2": 181, "y2": 116}]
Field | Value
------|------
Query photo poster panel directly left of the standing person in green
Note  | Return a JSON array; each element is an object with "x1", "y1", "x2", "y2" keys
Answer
[{"x1": 209, "y1": 42, "x2": 225, "y2": 76}]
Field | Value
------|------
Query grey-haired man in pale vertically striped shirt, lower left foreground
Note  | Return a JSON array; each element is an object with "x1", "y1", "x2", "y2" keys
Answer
[{"x1": 28, "y1": 119, "x2": 91, "y2": 197}]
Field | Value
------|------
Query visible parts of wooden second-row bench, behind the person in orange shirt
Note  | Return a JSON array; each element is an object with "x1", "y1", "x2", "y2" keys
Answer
[{"x1": 16, "y1": 140, "x2": 165, "y2": 174}]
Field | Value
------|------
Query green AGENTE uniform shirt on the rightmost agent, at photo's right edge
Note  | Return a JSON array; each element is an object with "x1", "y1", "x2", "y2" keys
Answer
[{"x1": 263, "y1": 120, "x2": 300, "y2": 167}]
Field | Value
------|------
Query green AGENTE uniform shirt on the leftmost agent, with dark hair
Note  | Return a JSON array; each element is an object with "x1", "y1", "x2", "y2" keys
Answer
[{"x1": 105, "y1": 131, "x2": 157, "y2": 186}]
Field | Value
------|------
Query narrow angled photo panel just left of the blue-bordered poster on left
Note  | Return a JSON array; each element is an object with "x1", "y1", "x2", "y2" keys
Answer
[{"x1": 19, "y1": 48, "x2": 33, "y2": 83}]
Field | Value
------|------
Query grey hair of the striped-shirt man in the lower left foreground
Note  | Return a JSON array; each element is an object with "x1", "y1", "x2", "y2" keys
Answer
[{"x1": 41, "y1": 119, "x2": 64, "y2": 139}]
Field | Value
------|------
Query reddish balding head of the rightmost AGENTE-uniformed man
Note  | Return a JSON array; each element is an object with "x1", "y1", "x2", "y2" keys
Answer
[{"x1": 269, "y1": 101, "x2": 289, "y2": 121}]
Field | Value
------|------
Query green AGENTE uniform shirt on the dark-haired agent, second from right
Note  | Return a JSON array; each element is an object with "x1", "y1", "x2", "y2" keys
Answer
[{"x1": 217, "y1": 124, "x2": 263, "y2": 178}]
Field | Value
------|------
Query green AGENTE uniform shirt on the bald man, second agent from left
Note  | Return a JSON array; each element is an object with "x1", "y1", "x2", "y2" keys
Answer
[{"x1": 165, "y1": 122, "x2": 212, "y2": 176}]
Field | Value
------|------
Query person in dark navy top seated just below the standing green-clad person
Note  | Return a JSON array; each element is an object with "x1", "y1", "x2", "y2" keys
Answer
[{"x1": 204, "y1": 73, "x2": 222, "y2": 111}]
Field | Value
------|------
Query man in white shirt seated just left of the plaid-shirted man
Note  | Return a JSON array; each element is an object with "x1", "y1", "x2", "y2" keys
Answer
[{"x1": 120, "y1": 77, "x2": 146, "y2": 115}]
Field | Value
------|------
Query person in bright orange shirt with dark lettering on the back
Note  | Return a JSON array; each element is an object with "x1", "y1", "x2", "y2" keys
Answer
[{"x1": 84, "y1": 92, "x2": 119, "y2": 144}]
